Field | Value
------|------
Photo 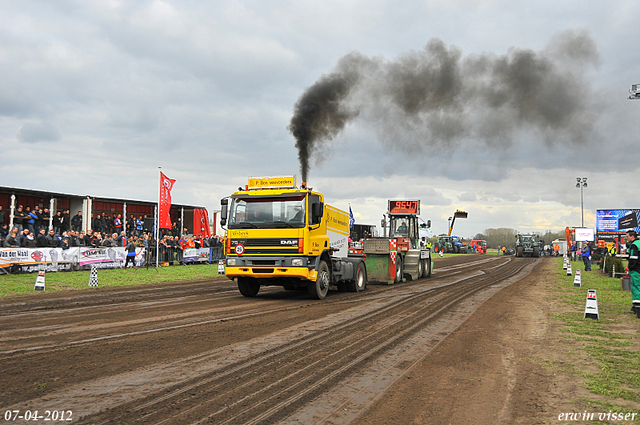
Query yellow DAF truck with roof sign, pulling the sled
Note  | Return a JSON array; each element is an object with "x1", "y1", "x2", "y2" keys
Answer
[{"x1": 220, "y1": 176, "x2": 367, "y2": 299}]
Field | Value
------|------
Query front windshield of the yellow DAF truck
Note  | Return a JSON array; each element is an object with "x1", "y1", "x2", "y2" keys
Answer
[{"x1": 229, "y1": 196, "x2": 306, "y2": 229}]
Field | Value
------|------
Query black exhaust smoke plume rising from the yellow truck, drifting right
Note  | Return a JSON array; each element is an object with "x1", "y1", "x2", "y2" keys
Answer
[{"x1": 288, "y1": 30, "x2": 598, "y2": 181}]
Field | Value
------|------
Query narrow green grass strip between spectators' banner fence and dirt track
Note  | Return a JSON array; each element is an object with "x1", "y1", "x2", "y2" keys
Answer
[{"x1": 0, "y1": 264, "x2": 225, "y2": 297}]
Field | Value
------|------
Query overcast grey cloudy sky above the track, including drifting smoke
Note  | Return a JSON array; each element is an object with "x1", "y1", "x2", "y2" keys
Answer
[{"x1": 0, "y1": 0, "x2": 640, "y2": 237}]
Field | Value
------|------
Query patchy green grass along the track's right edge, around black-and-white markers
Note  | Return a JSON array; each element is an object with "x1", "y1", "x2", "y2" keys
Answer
[{"x1": 554, "y1": 253, "x2": 640, "y2": 423}]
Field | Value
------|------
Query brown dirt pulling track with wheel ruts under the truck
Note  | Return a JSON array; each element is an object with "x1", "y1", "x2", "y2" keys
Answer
[{"x1": 0, "y1": 255, "x2": 549, "y2": 424}]
